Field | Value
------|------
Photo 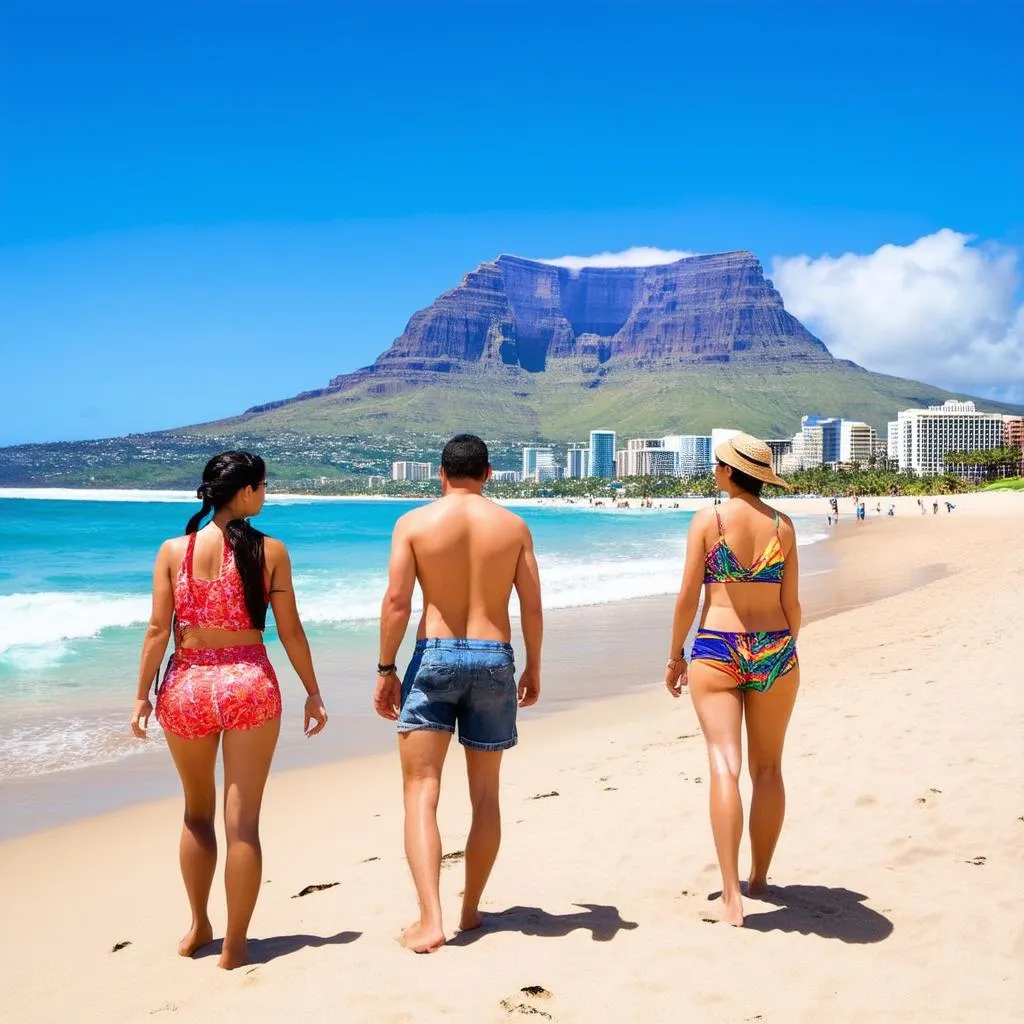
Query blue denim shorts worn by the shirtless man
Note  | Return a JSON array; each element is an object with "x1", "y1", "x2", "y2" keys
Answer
[{"x1": 398, "y1": 639, "x2": 519, "y2": 751}]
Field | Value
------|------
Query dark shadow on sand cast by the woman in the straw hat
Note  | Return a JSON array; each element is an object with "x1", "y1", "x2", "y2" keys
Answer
[{"x1": 733, "y1": 886, "x2": 893, "y2": 943}]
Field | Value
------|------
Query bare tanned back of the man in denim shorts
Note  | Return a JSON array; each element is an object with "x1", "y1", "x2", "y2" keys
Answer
[{"x1": 399, "y1": 492, "x2": 530, "y2": 643}]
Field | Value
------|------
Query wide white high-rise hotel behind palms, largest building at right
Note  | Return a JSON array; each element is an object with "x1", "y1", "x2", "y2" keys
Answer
[{"x1": 889, "y1": 400, "x2": 1004, "y2": 476}]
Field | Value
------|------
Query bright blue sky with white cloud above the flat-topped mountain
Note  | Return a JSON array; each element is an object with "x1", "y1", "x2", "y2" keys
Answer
[{"x1": 0, "y1": 0, "x2": 1024, "y2": 444}]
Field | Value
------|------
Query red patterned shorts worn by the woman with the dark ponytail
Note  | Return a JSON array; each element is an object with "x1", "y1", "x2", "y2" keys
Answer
[{"x1": 157, "y1": 643, "x2": 281, "y2": 739}]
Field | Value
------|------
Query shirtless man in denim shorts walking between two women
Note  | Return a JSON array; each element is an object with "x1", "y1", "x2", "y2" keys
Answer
[{"x1": 374, "y1": 434, "x2": 544, "y2": 953}]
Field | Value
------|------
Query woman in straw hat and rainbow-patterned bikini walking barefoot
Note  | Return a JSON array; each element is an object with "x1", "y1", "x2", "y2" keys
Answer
[{"x1": 665, "y1": 434, "x2": 801, "y2": 925}]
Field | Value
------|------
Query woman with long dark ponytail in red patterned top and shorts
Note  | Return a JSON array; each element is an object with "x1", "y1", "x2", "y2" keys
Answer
[{"x1": 131, "y1": 452, "x2": 327, "y2": 969}]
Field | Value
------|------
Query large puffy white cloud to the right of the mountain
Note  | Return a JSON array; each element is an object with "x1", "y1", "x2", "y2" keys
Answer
[{"x1": 771, "y1": 228, "x2": 1024, "y2": 401}]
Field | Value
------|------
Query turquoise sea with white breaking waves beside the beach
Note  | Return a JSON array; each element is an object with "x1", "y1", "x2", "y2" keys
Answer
[{"x1": 0, "y1": 492, "x2": 817, "y2": 835}]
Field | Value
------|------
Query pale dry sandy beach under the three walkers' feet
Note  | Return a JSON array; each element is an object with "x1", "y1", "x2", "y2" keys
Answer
[{"x1": 0, "y1": 495, "x2": 1024, "y2": 1024}]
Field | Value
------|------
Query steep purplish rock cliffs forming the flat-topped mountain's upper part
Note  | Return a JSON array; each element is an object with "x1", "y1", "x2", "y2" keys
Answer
[{"x1": 352, "y1": 252, "x2": 833, "y2": 387}]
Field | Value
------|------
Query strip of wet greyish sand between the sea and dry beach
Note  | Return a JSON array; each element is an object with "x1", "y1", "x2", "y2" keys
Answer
[{"x1": 0, "y1": 505, "x2": 950, "y2": 843}]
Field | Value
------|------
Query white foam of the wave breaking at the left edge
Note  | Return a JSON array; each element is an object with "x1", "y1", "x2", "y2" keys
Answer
[{"x1": 0, "y1": 591, "x2": 150, "y2": 659}]
